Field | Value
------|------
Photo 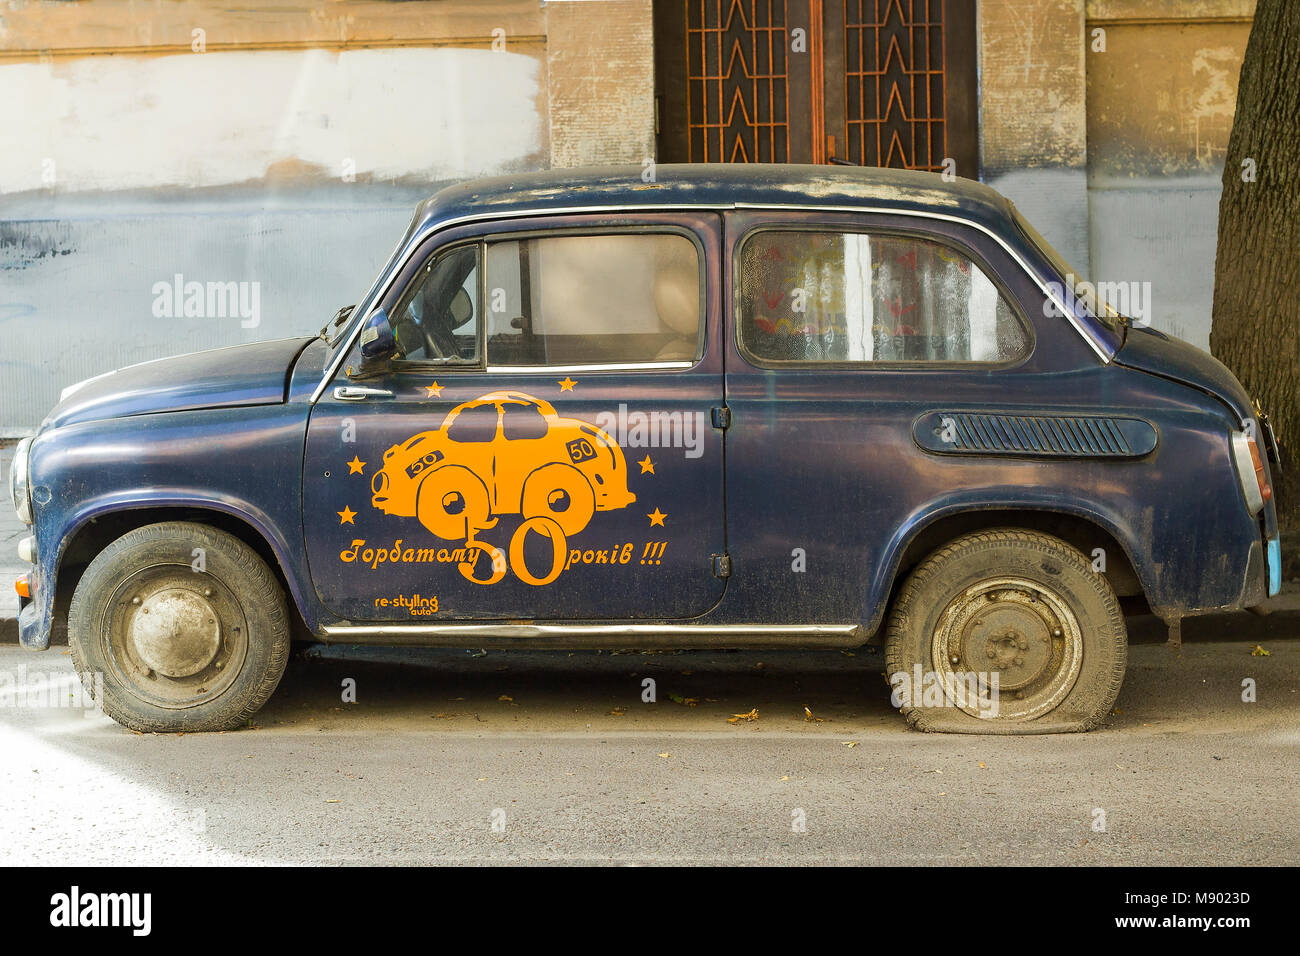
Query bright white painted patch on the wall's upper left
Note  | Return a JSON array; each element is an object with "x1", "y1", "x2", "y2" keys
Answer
[{"x1": 0, "y1": 48, "x2": 546, "y2": 194}]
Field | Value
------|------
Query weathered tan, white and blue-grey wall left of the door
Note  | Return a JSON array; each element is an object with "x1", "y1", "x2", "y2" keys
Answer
[{"x1": 0, "y1": 0, "x2": 654, "y2": 436}]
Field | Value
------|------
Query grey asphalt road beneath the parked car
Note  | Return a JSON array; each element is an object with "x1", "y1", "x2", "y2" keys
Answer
[{"x1": 0, "y1": 634, "x2": 1300, "y2": 866}]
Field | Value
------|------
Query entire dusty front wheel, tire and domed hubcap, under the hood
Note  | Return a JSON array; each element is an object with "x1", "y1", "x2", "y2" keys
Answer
[{"x1": 68, "y1": 522, "x2": 290, "y2": 732}]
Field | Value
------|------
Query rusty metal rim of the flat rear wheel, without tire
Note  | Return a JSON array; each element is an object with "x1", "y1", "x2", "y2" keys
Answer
[{"x1": 931, "y1": 578, "x2": 1083, "y2": 721}]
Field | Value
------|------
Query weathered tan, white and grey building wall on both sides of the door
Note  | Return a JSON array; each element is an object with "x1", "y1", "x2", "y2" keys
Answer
[{"x1": 0, "y1": 0, "x2": 1255, "y2": 436}]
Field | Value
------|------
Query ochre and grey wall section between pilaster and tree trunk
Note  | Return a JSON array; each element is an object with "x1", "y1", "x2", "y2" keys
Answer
[{"x1": 1088, "y1": 0, "x2": 1255, "y2": 349}]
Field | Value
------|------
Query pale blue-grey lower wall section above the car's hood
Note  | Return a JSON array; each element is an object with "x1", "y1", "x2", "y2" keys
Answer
[{"x1": 0, "y1": 195, "x2": 426, "y2": 434}]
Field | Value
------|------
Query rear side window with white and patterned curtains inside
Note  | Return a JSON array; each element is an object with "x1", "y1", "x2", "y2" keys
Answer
[{"x1": 738, "y1": 230, "x2": 1030, "y2": 363}]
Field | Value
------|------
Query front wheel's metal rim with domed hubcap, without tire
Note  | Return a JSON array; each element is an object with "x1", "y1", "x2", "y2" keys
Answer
[{"x1": 100, "y1": 564, "x2": 248, "y2": 710}]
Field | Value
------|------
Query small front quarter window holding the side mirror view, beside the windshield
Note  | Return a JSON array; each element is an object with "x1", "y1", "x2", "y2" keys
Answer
[{"x1": 389, "y1": 246, "x2": 480, "y2": 364}]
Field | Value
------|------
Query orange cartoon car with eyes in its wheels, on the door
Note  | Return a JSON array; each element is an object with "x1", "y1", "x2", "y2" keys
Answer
[{"x1": 371, "y1": 392, "x2": 637, "y2": 540}]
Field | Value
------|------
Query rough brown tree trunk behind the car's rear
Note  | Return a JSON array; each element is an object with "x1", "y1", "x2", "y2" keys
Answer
[{"x1": 1210, "y1": 0, "x2": 1300, "y2": 550}]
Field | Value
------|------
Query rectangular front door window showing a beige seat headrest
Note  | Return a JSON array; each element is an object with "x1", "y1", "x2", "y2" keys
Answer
[{"x1": 486, "y1": 233, "x2": 702, "y2": 365}]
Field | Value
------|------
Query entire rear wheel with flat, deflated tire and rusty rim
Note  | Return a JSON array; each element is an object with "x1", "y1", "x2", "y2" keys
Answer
[{"x1": 885, "y1": 528, "x2": 1128, "y2": 734}]
